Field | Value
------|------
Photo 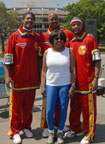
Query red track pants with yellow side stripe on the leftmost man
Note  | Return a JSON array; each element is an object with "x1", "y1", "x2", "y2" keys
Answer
[{"x1": 8, "y1": 90, "x2": 35, "y2": 136}]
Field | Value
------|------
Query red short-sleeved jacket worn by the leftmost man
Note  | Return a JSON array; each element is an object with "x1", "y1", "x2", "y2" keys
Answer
[{"x1": 4, "y1": 26, "x2": 41, "y2": 90}]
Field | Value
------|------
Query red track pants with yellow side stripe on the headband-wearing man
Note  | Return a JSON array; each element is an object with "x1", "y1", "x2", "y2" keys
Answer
[{"x1": 69, "y1": 93, "x2": 96, "y2": 140}]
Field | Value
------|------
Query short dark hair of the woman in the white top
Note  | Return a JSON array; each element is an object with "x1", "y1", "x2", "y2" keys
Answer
[{"x1": 49, "y1": 29, "x2": 66, "y2": 44}]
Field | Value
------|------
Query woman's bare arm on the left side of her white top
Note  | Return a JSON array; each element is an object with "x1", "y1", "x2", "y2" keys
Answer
[{"x1": 41, "y1": 50, "x2": 47, "y2": 96}]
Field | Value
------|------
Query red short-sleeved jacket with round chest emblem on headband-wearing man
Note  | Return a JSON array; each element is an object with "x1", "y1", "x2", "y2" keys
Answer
[{"x1": 70, "y1": 32, "x2": 101, "y2": 94}]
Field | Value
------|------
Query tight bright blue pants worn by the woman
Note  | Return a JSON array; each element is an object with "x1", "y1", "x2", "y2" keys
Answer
[{"x1": 46, "y1": 84, "x2": 70, "y2": 131}]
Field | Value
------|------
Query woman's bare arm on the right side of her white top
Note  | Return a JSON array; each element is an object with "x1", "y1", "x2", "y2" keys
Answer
[{"x1": 68, "y1": 50, "x2": 76, "y2": 98}]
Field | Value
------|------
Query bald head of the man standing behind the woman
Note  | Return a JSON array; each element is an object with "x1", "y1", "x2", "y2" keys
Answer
[{"x1": 48, "y1": 13, "x2": 59, "y2": 30}]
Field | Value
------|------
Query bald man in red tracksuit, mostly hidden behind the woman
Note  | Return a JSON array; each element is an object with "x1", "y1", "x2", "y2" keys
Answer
[{"x1": 41, "y1": 12, "x2": 74, "y2": 137}]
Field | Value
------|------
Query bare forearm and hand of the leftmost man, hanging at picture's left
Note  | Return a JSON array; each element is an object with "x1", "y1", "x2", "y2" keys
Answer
[{"x1": 4, "y1": 64, "x2": 12, "y2": 88}]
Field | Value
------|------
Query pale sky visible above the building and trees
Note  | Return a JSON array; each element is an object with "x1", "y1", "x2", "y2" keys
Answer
[{"x1": 0, "y1": 0, "x2": 79, "y2": 8}]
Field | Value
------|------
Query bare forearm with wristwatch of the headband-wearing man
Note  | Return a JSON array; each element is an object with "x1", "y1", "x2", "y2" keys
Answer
[{"x1": 90, "y1": 60, "x2": 101, "y2": 91}]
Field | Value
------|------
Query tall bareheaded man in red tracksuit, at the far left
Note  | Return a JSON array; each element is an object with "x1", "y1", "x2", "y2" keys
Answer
[{"x1": 4, "y1": 12, "x2": 42, "y2": 144}]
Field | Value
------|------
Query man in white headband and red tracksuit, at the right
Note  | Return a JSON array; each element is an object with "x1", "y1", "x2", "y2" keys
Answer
[{"x1": 65, "y1": 17, "x2": 101, "y2": 144}]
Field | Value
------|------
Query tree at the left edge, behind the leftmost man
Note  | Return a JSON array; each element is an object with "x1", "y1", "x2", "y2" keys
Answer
[{"x1": 0, "y1": 2, "x2": 18, "y2": 52}]
